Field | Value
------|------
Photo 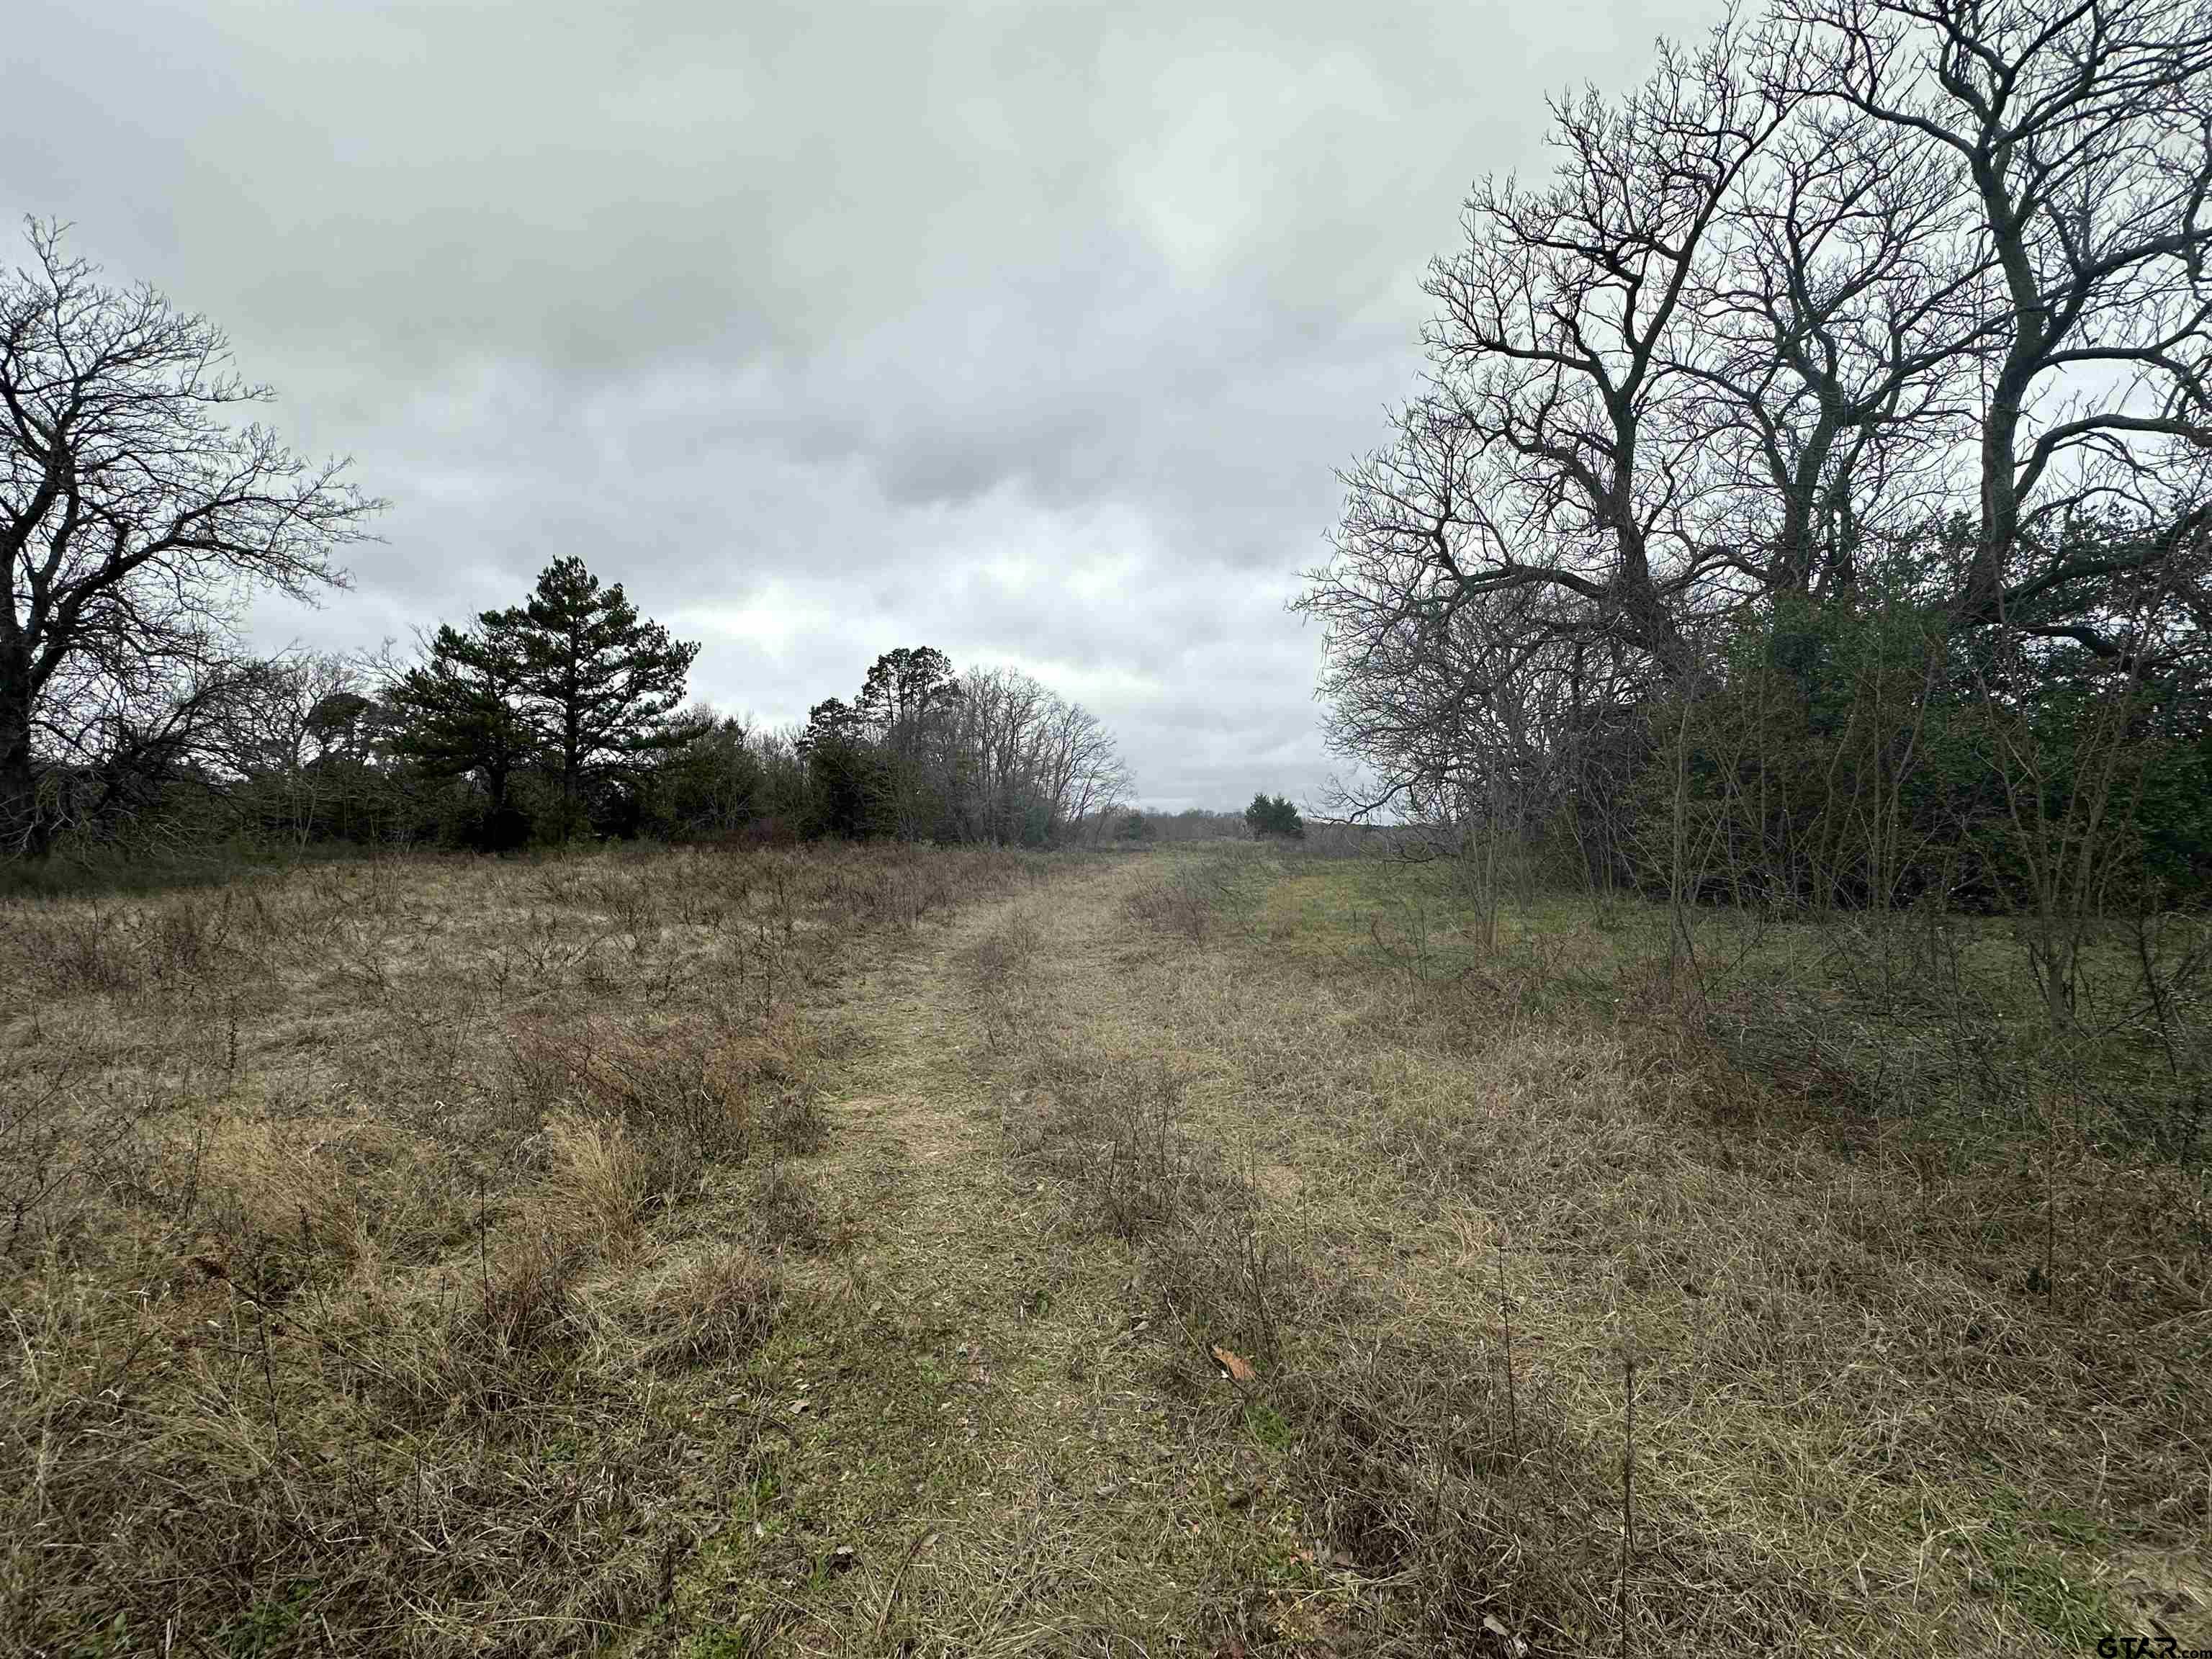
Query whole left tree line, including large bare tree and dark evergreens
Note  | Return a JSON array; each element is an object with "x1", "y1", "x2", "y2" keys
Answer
[{"x1": 0, "y1": 221, "x2": 1128, "y2": 858}]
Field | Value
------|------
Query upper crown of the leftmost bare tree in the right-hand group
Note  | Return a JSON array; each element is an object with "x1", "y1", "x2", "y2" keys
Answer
[{"x1": 1398, "y1": 24, "x2": 1783, "y2": 673}]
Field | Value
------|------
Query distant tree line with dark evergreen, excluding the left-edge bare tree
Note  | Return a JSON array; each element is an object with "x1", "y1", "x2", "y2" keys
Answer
[{"x1": 42, "y1": 557, "x2": 1128, "y2": 852}]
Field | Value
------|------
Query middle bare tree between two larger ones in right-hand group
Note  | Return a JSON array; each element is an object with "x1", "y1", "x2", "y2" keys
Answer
[{"x1": 1670, "y1": 44, "x2": 1989, "y2": 597}]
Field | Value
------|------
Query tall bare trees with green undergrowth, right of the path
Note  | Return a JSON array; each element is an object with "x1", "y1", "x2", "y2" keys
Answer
[{"x1": 1296, "y1": 0, "x2": 2212, "y2": 938}]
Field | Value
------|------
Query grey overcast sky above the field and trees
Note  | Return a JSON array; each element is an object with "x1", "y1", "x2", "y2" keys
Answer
[{"x1": 0, "y1": 0, "x2": 1717, "y2": 807}]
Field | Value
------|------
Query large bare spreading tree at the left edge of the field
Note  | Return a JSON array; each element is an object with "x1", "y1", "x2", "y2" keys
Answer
[{"x1": 0, "y1": 221, "x2": 380, "y2": 854}]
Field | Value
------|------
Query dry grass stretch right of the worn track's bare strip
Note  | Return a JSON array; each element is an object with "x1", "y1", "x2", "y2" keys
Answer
[{"x1": 1022, "y1": 850, "x2": 2212, "y2": 1655}]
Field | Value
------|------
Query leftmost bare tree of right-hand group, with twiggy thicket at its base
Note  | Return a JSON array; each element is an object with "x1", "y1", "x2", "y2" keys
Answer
[{"x1": 1296, "y1": 20, "x2": 1787, "y2": 863}]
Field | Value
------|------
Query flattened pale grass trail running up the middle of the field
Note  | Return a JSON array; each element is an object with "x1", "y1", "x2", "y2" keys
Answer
[{"x1": 664, "y1": 858, "x2": 1303, "y2": 1655}]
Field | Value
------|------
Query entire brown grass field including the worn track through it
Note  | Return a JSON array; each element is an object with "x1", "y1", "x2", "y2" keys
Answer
[{"x1": 0, "y1": 845, "x2": 2212, "y2": 1659}]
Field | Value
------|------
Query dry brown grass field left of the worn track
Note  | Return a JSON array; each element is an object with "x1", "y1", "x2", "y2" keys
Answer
[{"x1": 0, "y1": 850, "x2": 1042, "y2": 1655}]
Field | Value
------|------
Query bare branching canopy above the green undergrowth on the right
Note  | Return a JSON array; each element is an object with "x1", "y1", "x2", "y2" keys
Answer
[{"x1": 1296, "y1": 0, "x2": 2212, "y2": 827}]
